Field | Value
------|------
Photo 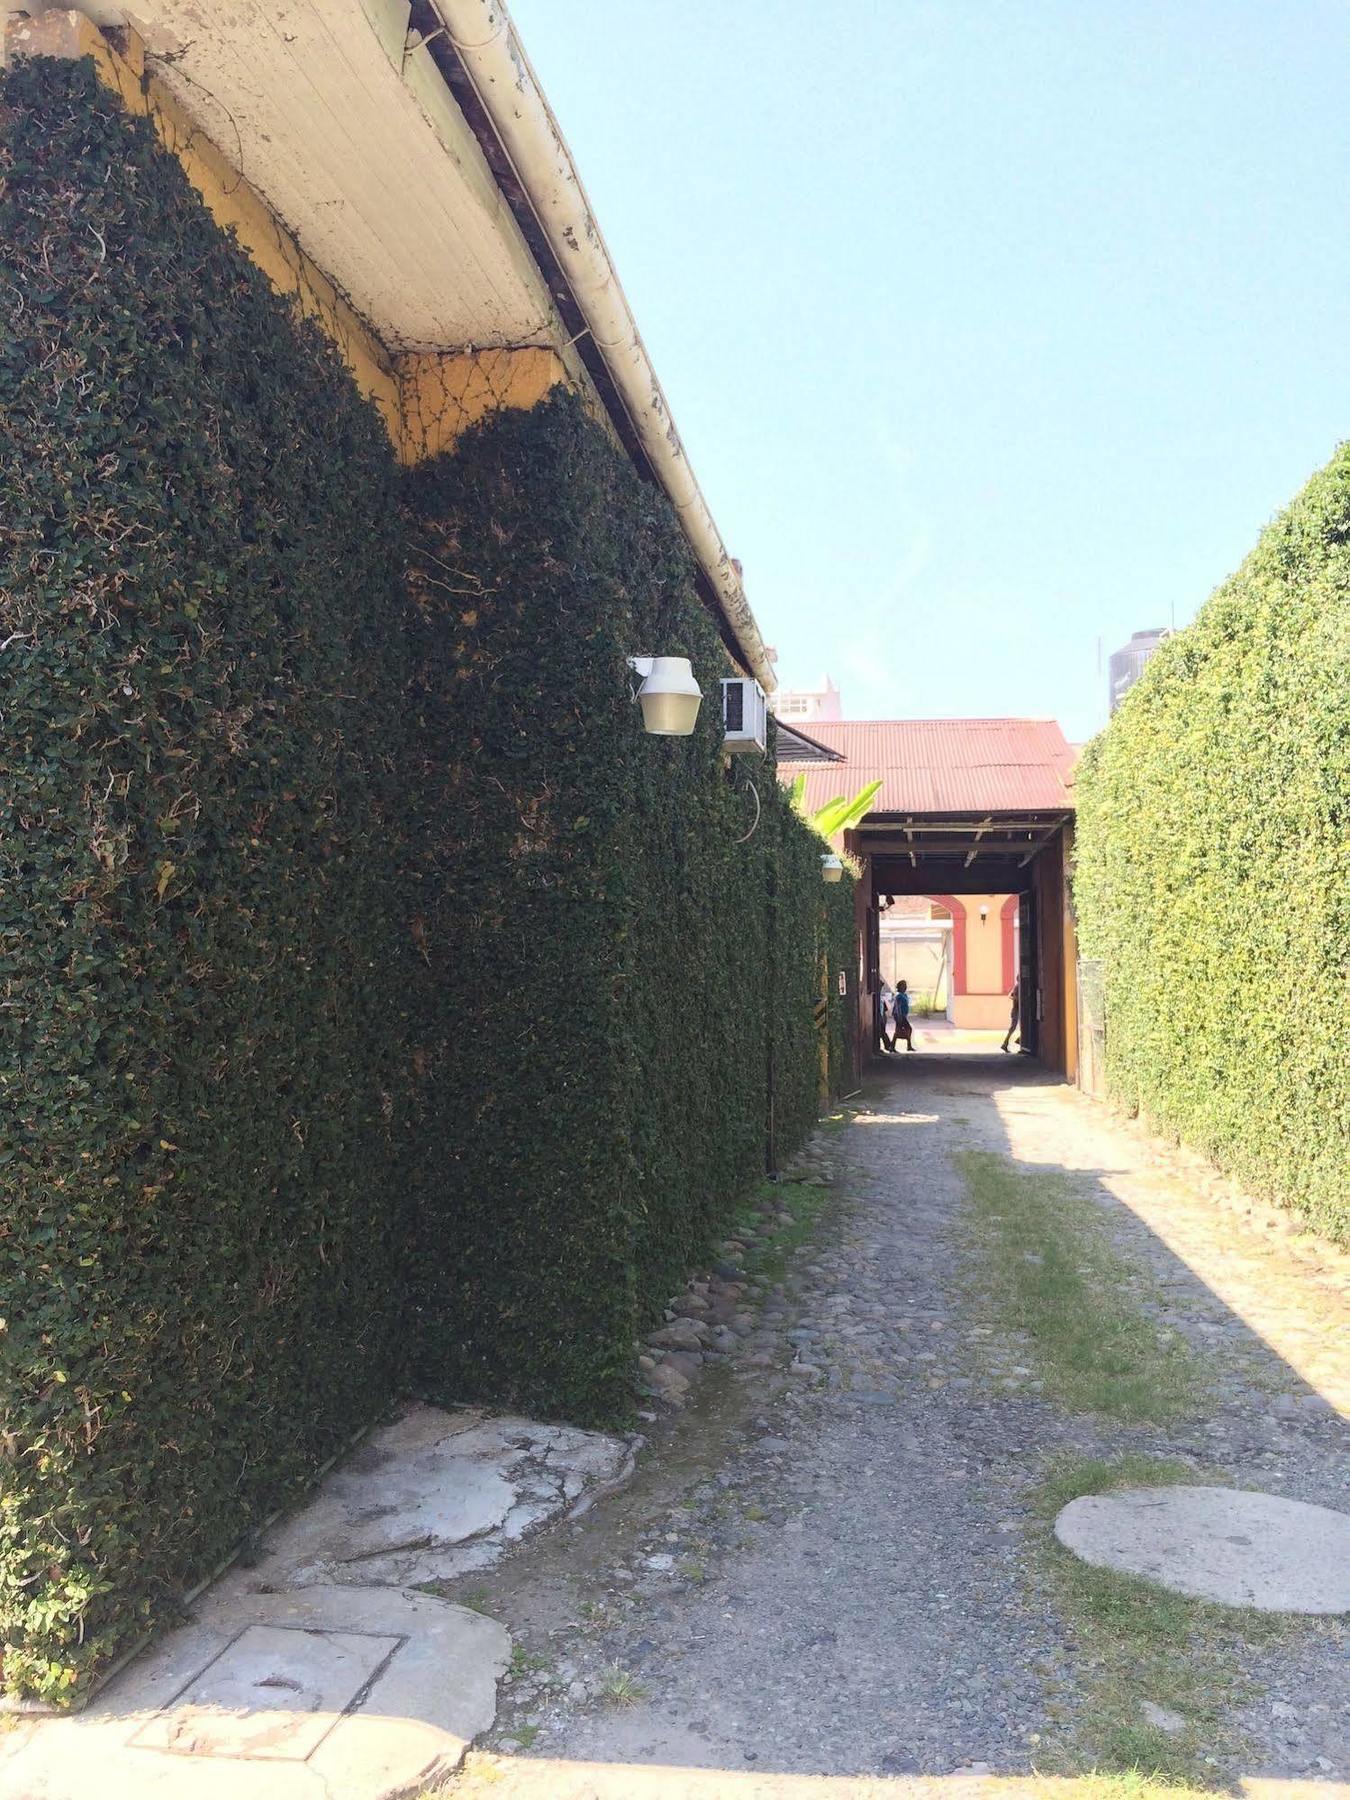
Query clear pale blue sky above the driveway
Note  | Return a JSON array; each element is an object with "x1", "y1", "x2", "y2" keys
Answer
[{"x1": 511, "y1": 0, "x2": 1350, "y2": 738}]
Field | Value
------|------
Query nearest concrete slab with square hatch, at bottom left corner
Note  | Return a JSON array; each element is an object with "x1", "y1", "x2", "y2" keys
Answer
[{"x1": 0, "y1": 1571, "x2": 511, "y2": 1800}]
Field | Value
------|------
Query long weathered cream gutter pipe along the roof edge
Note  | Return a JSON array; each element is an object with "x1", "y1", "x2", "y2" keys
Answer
[{"x1": 428, "y1": 0, "x2": 778, "y2": 693}]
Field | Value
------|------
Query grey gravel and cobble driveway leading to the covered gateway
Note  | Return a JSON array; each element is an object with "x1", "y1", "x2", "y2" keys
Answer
[{"x1": 446, "y1": 1057, "x2": 1350, "y2": 1796}]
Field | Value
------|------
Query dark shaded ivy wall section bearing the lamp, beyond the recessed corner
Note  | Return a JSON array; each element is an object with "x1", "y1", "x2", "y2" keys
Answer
[{"x1": 409, "y1": 396, "x2": 856, "y2": 1418}]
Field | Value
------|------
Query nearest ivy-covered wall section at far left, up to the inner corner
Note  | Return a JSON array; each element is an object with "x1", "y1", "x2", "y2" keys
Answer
[{"x1": 0, "y1": 49, "x2": 421, "y2": 1694}]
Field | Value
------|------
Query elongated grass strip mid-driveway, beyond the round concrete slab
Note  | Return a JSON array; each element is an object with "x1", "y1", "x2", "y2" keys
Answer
[{"x1": 954, "y1": 1150, "x2": 1206, "y2": 1422}]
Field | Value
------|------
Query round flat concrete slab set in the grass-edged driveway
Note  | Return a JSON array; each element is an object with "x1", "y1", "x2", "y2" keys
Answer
[{"x1": 1055, "y1": 1487, "x2": 1350, "y2": 1613}]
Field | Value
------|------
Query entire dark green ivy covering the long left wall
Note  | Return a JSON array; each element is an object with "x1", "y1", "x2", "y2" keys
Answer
[{"x1": 0, "y1": 61, "x2": 856, "y2": 1697}]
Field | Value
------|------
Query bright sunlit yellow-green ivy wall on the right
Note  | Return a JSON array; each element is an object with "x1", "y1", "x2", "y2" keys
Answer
[{"x1": 1075, "y1": 445, "x2": 1350, "y2": 1238}]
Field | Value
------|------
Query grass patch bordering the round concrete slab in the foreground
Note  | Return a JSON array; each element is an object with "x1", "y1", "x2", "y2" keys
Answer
[{"x1": 1031, "y1": 1456, "x2": 1294, "y2": 1800}]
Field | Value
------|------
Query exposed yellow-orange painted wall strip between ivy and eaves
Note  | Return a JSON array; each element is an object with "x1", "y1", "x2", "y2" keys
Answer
[{"x1": 4, "y1": 9, "x2": 567, "y2": 463}]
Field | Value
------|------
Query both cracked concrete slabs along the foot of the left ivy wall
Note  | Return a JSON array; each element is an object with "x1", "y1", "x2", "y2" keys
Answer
[{"x1": 0, "y1": 1406, "x2": 635, "y2": 1800}]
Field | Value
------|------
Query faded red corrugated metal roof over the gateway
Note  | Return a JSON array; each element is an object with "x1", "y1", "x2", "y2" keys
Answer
[{"x1": 779, "y1": 718, "x2": 1076, "y2": 814}]
